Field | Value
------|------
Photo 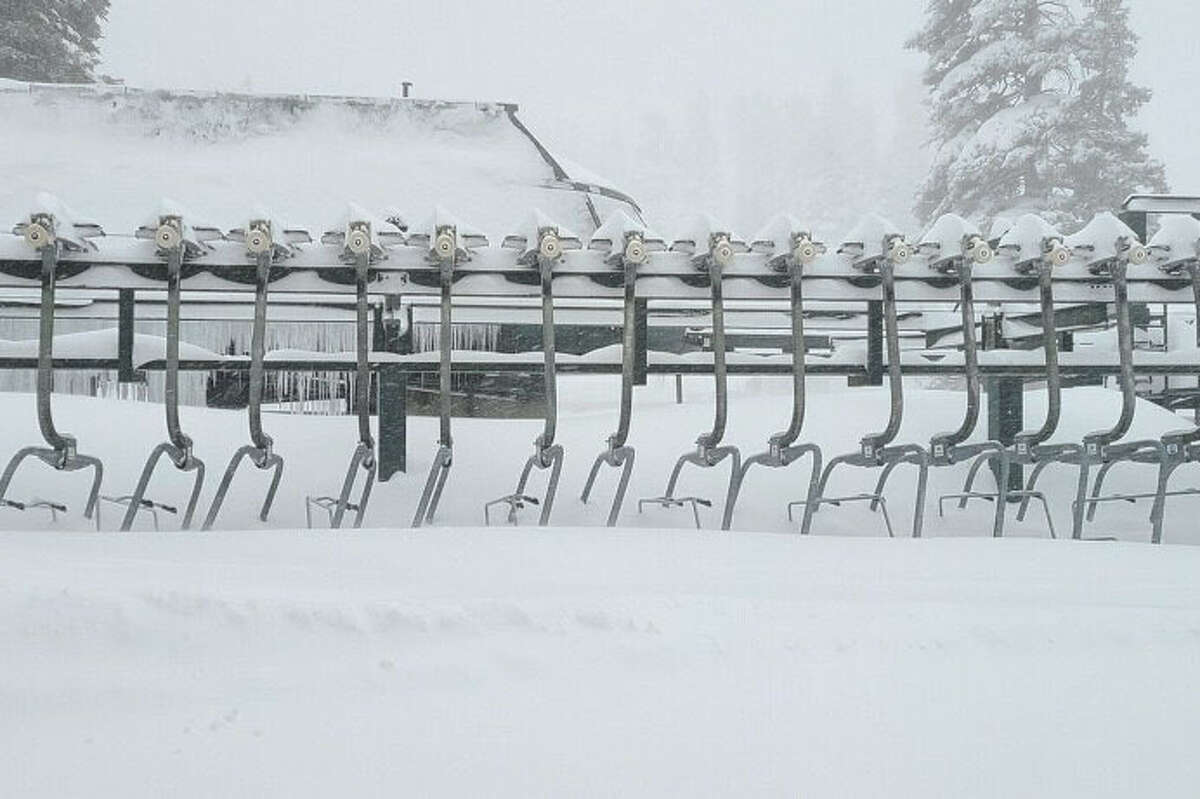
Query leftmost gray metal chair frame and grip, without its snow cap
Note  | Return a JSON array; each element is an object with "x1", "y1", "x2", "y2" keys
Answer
[{"x1": 0, "y1": 212, "x2": 104, "y2": 529}]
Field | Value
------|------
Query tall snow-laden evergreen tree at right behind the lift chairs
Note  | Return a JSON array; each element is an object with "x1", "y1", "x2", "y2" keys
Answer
[{"x1": 908, "y1": 0, "x2": 1166, "y2": 223}]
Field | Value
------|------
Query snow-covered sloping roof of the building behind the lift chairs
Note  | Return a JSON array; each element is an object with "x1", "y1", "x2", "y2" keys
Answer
[{"x1": 0, "y1": 80, "x2": 637, "y2": 241}]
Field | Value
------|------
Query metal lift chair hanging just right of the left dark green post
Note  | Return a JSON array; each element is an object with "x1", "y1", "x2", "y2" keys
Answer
[{"x1": 408, "y1": 209, "x2": 487, "y2": 527}]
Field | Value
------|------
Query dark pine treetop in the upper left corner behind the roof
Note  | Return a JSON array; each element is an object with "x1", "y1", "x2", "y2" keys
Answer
[{"x1": 0, "y1": 0, "x2": 109, "y2": 83}]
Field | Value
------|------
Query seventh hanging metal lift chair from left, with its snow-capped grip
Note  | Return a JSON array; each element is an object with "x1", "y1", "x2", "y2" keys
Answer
[{"x1": 580, "y1": 210, "x2": 666, "y2": 527}]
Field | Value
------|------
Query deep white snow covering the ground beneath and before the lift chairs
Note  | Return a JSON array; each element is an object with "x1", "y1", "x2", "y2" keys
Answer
[{"x1": 0, "y1": 378, "x2": 1200, "y2": 797}]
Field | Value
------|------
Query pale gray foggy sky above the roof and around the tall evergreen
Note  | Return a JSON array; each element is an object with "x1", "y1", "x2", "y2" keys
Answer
[{"x1": 102, "y1": 0, "x2": 1200, "y2": 228}]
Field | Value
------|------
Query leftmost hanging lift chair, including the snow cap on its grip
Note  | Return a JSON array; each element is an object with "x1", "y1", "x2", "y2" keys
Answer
[{"x1": 0, "y1": 194, "x2": 104, "y2": 529}]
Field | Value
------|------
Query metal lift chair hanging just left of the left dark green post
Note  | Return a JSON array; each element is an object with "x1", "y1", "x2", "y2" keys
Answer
[{"x1": 305, "y1": 205, "x2": 403, "y2": 530}]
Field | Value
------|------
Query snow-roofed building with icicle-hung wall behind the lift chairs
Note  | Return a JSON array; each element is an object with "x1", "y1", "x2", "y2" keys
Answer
[{"x1": 0, "y1": 80, "x2": 641, "y2": 404}]
